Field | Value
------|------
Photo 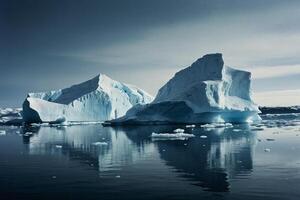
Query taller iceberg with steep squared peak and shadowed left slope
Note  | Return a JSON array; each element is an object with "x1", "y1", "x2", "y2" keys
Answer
[{"x1": 107, "y1": 53, "x2": 260, "y2": 125}]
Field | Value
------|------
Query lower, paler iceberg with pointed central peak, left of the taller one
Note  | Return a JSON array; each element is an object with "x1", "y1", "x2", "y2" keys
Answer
[{"x1": 22, "y1": 74, "x2": 153, "y2": 123}]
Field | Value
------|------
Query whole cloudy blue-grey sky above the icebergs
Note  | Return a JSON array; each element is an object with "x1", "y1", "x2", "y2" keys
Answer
[{"x1": 0, "y1": 0, "x2": 300, "y2": 107}]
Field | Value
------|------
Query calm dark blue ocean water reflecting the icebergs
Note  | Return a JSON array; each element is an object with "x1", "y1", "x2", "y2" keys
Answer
[{"x1": 0, "y1": 114, "x2": 300, "y2": 200}]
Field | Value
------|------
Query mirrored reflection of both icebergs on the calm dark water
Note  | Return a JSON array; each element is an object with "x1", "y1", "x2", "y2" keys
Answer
[{"x1": 23, "y1": 125, "x2": 256, "y2": 192}]
